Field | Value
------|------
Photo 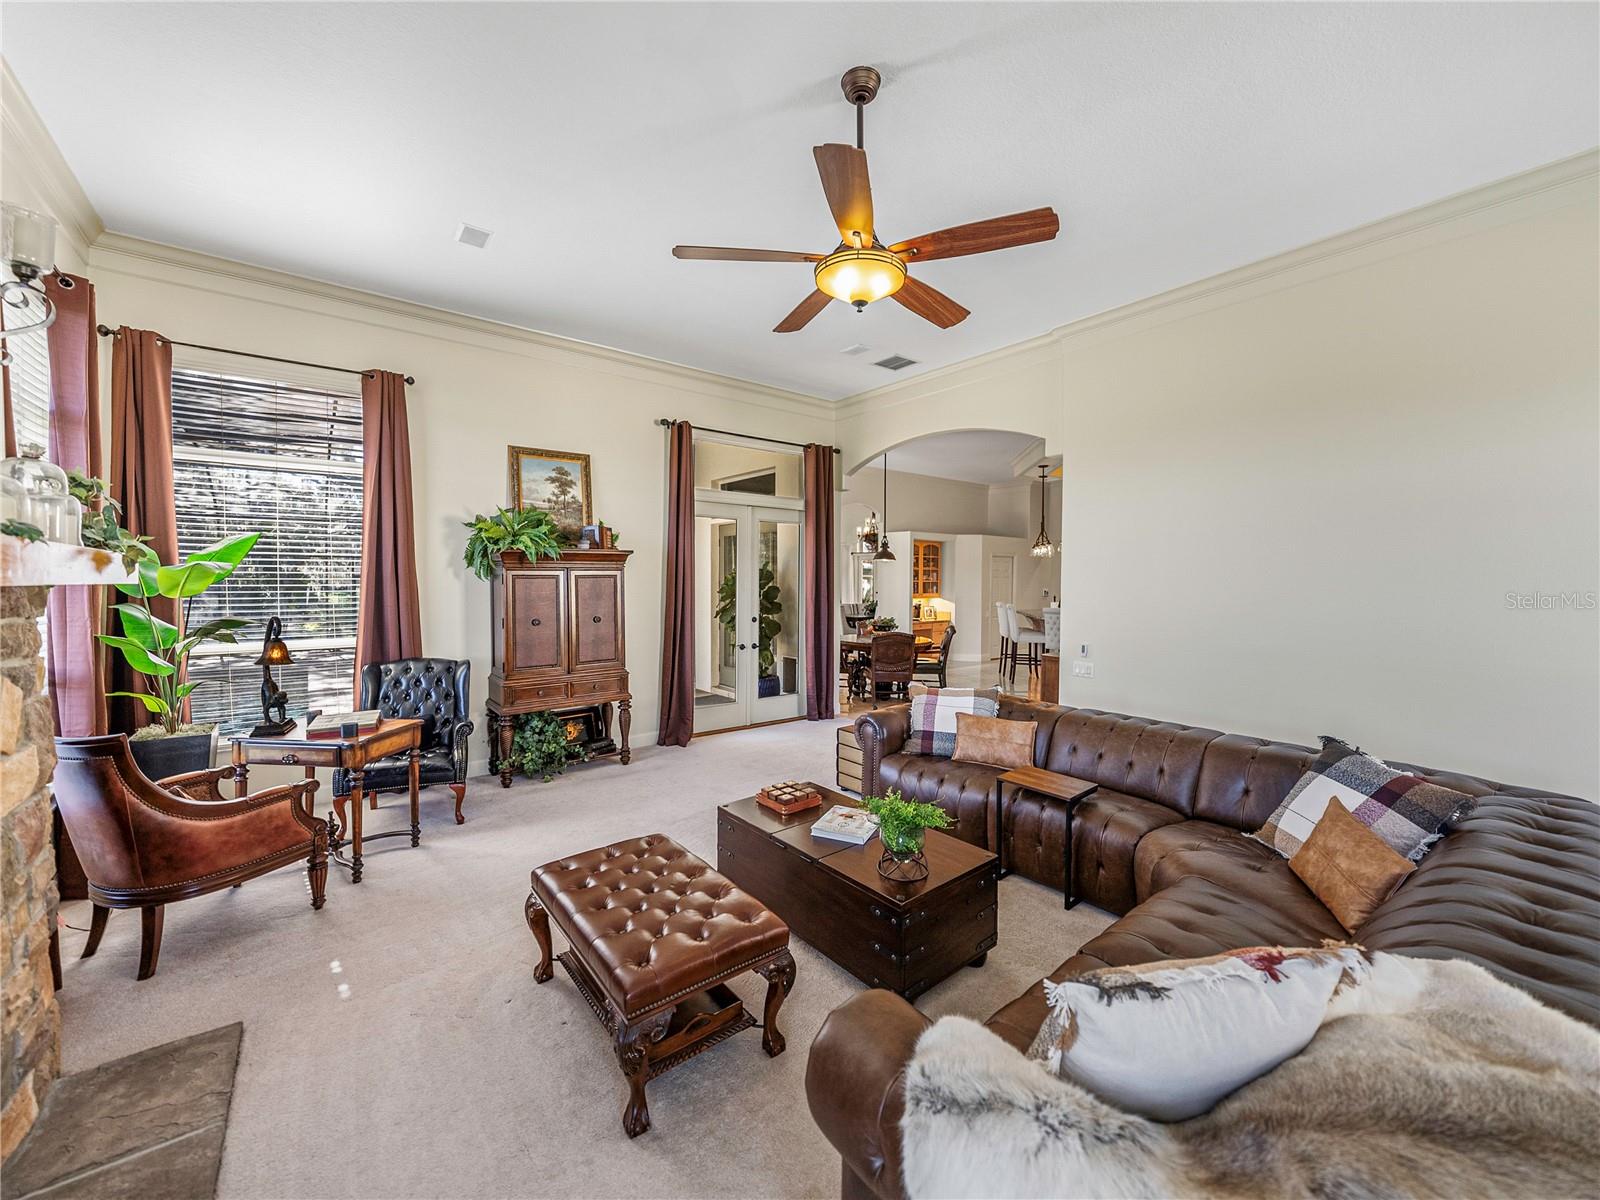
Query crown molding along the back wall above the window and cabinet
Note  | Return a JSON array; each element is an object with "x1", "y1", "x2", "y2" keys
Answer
[{"x1": 90, "y1": 232, "x2": 834, "y2": 421}]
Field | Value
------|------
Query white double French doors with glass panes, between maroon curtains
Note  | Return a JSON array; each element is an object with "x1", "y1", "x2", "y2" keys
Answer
[{"x1": 694, "y1": 493, "x2": 805, "y2": 733}]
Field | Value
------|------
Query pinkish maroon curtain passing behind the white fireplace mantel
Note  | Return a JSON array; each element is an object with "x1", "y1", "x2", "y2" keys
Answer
[{"x1": 45, "y1": 274, "x2": 106, "y2": 738}]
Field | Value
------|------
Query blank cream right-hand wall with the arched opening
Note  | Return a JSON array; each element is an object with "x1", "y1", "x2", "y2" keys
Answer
[{"x1": 838, "y1": 154, "x2": 1600, "y2": 798}]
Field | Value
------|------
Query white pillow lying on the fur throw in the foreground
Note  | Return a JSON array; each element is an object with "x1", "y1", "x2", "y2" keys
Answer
[{"x1": 1027, "y1": 944, "x2": 1368, "y2": 1122}]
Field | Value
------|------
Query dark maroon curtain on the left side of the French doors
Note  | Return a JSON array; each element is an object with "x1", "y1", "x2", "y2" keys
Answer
[{"x1": 656, "y1": 421, "x2": 694, "y2": 746}]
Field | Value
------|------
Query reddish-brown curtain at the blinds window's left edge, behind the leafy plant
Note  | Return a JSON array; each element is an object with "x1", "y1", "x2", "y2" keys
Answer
[{"x1": 109, "y1": 325, "x2": 187, "y2": 733}]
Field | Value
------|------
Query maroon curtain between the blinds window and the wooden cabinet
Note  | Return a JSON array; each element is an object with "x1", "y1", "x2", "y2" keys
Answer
[{"x1": 350, "y1": 371, "x2": 422, "y2": 704}]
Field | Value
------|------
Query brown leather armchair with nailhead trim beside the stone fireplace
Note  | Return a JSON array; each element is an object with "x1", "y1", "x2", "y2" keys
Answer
[{"x1": 53, "y1": 733, "x2": 328, "y2": 979}]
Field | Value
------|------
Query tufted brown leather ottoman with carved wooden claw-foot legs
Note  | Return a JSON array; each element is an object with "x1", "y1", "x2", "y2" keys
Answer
[{"x1": 525, "y1": 834, "x2": 795, "y2": 1138}]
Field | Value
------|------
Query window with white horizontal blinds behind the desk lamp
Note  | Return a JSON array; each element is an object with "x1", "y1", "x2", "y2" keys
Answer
[{"x1": 173, "y1": 366, "x2": 362, "y2": 734}]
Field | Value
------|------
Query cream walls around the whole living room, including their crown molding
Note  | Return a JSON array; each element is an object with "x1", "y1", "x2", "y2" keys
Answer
[{"x1": 0, "y1": 58, "x2": 1600, "y2": 797}]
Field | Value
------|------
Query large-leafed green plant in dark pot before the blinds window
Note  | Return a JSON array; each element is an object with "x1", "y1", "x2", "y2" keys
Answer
[{"x1": 98, "y1": 533, "x2": 261, "y2": 779}]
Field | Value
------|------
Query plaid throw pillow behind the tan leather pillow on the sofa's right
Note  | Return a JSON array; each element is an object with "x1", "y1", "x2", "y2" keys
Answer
[{"x1": 1250, "y1": 738, "x2": 1475, "y2": 862}]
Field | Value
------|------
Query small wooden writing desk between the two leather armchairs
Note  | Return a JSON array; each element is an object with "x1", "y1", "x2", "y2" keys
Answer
[{"x1": 234, "y1": 717, "x2": 422, "y2": 883}]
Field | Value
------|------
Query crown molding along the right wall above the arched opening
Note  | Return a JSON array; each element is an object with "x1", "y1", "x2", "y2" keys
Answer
[{"x1": 835, "y1": 149, "x2": 1600, "y2": 421}]
